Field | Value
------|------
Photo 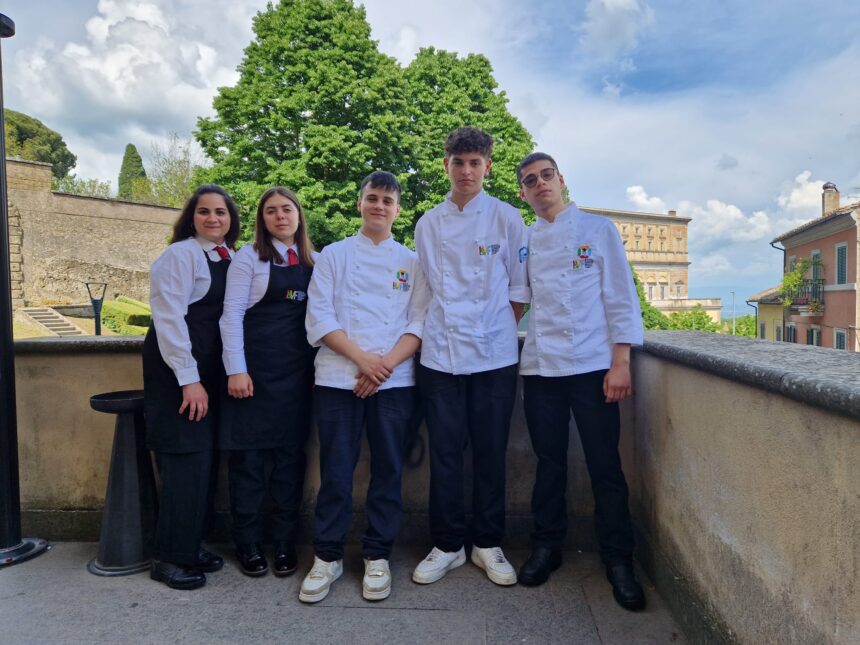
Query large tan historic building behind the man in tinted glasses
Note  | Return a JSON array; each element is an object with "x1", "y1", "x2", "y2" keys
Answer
[{"x1": 580, "y1": 206, "x2": 721, "y2": 322}]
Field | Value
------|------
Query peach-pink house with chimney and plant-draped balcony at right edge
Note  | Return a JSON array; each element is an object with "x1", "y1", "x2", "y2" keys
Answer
[{"x1": 773, "y1": 183, "x2": 860, "y2": 352}]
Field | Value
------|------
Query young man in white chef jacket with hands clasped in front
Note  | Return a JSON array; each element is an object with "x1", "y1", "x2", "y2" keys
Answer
[{"x1": 299, "y1": 171, "x2": 429, "y2": 603}]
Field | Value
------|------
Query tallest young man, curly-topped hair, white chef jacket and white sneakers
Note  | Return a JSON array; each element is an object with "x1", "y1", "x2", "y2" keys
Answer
[{"x1": 412, "y1": 127, "x2": 530, "y2": 585}]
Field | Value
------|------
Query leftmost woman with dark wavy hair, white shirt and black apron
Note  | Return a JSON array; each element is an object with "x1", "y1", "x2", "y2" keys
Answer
[{"x1": 143, "y1": 184, "x2": 239, "y2": 589}]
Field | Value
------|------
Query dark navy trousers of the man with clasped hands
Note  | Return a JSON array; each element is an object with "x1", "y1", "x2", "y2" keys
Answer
[{"x1": 314, "y1": 386, "x2": 416, "y2": 562}]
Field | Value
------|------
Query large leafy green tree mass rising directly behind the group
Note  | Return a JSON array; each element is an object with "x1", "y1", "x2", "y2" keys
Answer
[{"x1": 195, "y1": 0, "x2": 533, "y2": 247}]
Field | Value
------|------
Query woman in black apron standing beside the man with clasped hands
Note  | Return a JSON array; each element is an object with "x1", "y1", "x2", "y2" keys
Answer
[{"x1": 219, "y1": 188, "x2": 314, "y2": 576}]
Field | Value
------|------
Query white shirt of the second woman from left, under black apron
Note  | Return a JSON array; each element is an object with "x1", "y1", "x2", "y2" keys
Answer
[{"x1": 220, "y1": 238, "x2": 298, "y2": 376}]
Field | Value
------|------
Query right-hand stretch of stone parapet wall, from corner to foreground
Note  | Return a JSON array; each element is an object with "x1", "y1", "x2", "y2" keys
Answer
[{"x1": 623, "y1": 332, "x2": 860, "y2": 643}]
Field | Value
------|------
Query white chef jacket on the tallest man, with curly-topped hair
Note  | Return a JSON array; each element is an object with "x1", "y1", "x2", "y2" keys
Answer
[{"x1": 415, "y1": 191, "x2": 531, "y2": 374}]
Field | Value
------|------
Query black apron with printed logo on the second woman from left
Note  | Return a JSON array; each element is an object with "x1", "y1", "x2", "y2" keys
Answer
[{"x1": 219, "y1": 262, "x2": 315, "y2": 450}]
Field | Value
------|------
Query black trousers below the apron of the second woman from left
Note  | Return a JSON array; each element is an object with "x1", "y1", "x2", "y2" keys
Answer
[{"x1": 229, "y1": 442, "x2": 305, "y2": 544}]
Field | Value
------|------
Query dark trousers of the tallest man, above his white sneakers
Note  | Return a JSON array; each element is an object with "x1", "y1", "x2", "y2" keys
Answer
[{"x1": 418, "y1": 365, "x2": 517, "y2": 552}]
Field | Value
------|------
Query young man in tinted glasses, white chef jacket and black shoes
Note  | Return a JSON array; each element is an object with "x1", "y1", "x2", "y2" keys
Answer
[{"x1": 510, "y1": 152, "x2": 645, "y2": 609}]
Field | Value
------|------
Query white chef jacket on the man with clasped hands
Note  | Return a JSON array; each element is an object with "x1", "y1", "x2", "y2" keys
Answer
[{"x1": 305, "y1": 232, "x2": 430, "y2": 390}]
